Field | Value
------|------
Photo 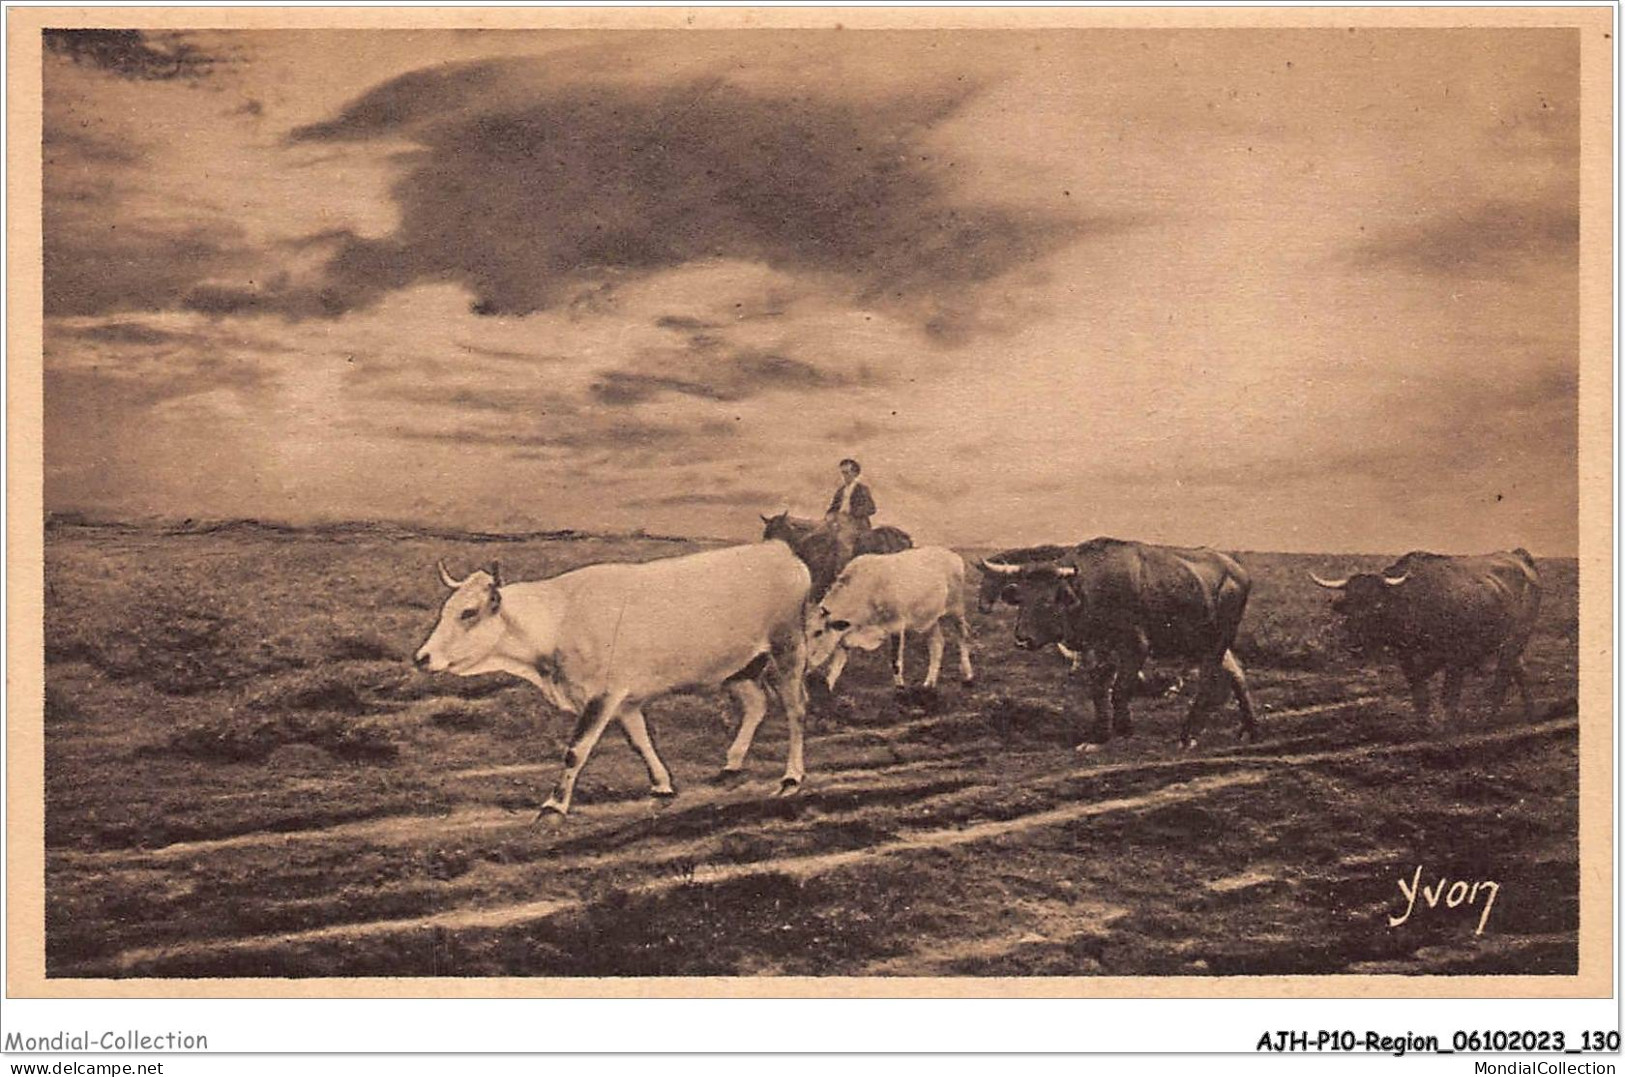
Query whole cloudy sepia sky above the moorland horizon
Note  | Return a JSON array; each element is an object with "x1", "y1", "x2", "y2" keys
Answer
[{"x1": 44, "y1": 29, "x2": 1580, "y2": 554}]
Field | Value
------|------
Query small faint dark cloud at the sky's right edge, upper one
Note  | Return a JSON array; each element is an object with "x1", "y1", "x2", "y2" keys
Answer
[{"x1": 1355, "y1": 201, "x2": 1580, "y2": 278}]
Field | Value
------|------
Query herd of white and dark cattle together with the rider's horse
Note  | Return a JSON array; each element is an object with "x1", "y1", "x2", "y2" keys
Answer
[{"x1": 416, "y1": 515, "x2": 1541, "y2": 817}]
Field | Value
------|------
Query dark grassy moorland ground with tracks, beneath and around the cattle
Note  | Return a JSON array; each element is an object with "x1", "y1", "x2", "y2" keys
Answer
[{"x1": 41, "y1": 521, "x2": 1578, "y2": 978}]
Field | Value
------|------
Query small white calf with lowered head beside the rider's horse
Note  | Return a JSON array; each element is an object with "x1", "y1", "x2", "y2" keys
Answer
[{"x1": 808, "y1": 546, "x2": 975, "y2": 690}]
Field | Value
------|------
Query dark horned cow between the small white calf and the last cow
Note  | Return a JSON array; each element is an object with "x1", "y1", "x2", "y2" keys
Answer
[{"x1": 978, "y1": 538, "x2": 1258, "y2": 750}]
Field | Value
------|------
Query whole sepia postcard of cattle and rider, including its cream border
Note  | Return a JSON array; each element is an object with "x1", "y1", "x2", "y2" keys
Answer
[{"x1": 8, "y1": 8, "x2": 1615, "y2": 996}]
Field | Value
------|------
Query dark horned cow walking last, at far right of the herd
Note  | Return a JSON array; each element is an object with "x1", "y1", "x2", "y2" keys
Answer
[{"x1": 1310, "y1": 549, "x2": 1541, "y2": 721}]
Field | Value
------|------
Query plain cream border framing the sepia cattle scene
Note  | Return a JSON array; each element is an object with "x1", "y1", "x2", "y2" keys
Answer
[{"x1": 5, "y1": 6, "x2": 1615, "y2": 999}]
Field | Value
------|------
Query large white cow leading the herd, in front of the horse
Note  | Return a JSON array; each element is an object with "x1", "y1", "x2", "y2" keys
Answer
[{"x1": 416, "y1": 543, "x2": 811, "y2": 815}]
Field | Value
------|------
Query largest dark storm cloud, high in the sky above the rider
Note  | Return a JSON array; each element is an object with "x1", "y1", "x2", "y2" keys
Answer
[{"x1": 291, "y1": 60, "x2": 1089, "y2": 321}]
